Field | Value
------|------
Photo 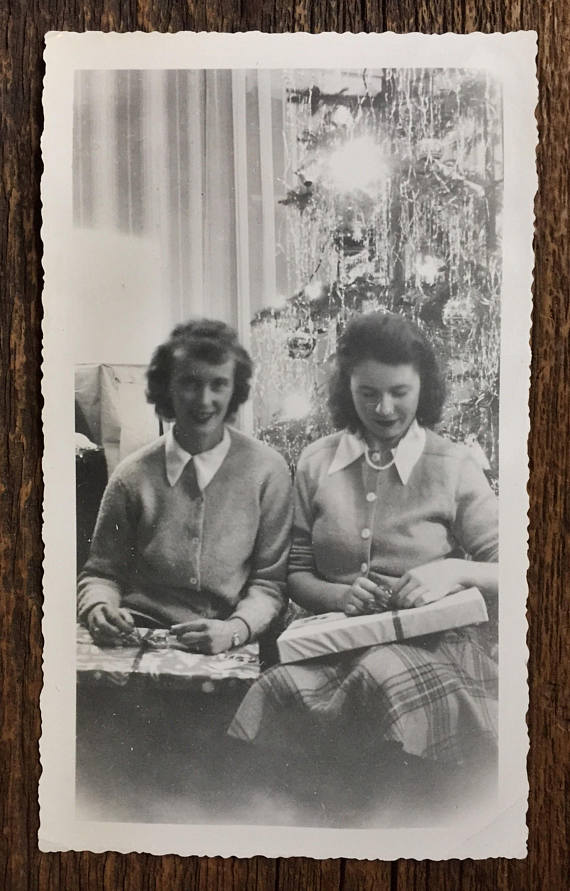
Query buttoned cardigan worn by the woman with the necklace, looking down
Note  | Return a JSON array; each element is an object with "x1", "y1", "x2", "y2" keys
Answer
[{"x1": 289, "y1": 430, "x2": 498, "y2": 585}]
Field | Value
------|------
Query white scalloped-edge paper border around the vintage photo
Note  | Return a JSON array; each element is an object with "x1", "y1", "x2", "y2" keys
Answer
[{"x1": 39, "y1": 31, "x2": 538, "y2": 860}]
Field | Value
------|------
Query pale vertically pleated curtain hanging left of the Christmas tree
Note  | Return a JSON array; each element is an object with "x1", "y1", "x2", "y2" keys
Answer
[{"x1": 73, "y1": 70, "x2": 287, "y2": 426}]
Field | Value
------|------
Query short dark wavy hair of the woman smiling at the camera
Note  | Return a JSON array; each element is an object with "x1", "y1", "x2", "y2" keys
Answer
[{"x1": 146, "y1": 319, "x2": 253, "y2": 421}]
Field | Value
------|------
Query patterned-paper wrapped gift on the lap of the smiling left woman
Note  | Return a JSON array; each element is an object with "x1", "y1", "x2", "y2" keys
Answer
[{"x1": 77, "y1": 626, "x2": 260, "y2": 692}]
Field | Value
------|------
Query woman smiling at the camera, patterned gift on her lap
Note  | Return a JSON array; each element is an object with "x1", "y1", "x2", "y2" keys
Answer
[{"x1": 78, "y1": 319, "x2": 291, "y2": 653}]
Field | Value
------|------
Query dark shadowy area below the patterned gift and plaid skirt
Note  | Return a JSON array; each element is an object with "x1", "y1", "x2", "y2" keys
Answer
[{"x1": 76, "y1": 683, "x2": 496, "y2": 828}]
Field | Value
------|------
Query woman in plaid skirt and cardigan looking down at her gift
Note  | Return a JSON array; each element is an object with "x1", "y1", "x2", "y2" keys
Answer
[{"x1": 230, "y1": 313, "x2": 498, "y2": 808}]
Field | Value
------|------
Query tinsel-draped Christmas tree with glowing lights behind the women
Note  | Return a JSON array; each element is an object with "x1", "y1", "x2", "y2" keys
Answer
[{"x1": 252, "y1": 69, "x2": 502, "y2": 481}]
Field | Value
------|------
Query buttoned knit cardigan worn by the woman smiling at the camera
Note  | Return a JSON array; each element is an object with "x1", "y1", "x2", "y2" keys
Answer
[{"x1": 78, "y1": 428, "x2": 292, "y2": 636}]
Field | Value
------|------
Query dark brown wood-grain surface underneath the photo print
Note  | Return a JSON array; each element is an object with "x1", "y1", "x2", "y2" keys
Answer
[{"x1": 0, "y1": 0, "x2": 570, "y2": 891}]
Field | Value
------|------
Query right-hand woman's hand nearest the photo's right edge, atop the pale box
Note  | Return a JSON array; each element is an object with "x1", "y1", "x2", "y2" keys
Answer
[{"x1": 391, "y1": 559, "x2": 465, "y2": 609}]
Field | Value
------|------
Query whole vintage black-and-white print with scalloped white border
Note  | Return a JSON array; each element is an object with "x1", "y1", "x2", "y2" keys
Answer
[{"x1": 40, "y1": 34, "x2": 536, "y2": 858}]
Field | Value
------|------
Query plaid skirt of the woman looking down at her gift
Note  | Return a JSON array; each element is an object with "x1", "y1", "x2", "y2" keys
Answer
[{"x1": 228, "y1": 628, "x2": 498, "y2": 763}]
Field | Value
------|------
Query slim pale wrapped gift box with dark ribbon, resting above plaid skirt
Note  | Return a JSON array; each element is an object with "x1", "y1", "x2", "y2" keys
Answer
[{"x1": 277, "y1": 588, "x2": 488, "y2": 662}]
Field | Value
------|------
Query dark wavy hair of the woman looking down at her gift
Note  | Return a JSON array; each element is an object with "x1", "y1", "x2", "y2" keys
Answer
[{"x1": 328, "y1": 312, "x2": 445, "y2": 433}]
